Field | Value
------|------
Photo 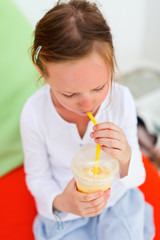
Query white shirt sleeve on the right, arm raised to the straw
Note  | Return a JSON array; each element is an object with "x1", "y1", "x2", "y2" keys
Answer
[{"x1": 118, "y1": 88, "x2": 146, "y2": 188}]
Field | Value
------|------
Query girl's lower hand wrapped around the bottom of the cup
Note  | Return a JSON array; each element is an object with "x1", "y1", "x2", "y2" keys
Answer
[{"x1": 53, "y1": 178, "x2": 110, "y2": 217}]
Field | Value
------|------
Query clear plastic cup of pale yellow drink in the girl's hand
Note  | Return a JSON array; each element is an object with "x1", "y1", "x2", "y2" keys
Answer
[{"x1": 72, "y1": 145, "x2": 119, "y2": 193}]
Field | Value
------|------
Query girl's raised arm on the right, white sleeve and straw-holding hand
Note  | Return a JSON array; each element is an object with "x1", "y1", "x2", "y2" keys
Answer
[{"x1": 91, "y1": 88, "x2": 145, "y2": 188}]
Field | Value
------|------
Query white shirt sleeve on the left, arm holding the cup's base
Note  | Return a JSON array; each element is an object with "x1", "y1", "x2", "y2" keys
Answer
[{"x1": 20, "y1": 101, "x2": 64, "y2": 219}]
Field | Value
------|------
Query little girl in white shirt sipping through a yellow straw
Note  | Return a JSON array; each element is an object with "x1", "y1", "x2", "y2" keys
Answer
[{"x1": 21, "y1": 0, "x2": 154, "y2": 240}]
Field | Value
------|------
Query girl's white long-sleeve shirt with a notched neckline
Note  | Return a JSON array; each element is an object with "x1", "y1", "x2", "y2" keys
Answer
[{"x1": 20, "y1": 83, "x2": 145, "y2": 221}]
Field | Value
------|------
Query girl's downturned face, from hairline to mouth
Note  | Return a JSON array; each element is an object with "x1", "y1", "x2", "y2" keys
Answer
[{"x1": 46, "y1": 52, "x2": 111, "y2": 116}]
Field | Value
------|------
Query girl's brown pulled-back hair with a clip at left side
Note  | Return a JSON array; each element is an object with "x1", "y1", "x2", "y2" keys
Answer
[{"x1": 31, "y1": 0, "x2": 116, "y2": 79}]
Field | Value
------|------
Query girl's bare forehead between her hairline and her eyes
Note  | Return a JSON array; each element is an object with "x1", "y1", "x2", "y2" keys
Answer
[{"x1": 46, "y1": 53, "x2": 109, "y2": 92}]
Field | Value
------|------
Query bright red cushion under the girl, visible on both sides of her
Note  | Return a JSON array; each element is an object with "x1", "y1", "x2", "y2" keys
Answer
[{"x1": 0, "y1": 156, "x2": 160, "y2": 240}]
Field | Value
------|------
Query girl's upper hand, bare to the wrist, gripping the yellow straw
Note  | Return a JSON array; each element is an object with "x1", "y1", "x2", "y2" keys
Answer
[{"x1": 90, "y1": 122, "x2": 131, "y2": 176}]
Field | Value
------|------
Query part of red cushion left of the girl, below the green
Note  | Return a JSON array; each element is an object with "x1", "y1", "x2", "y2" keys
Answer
[{"x1": 0, "y1": 167, "x2": 36, "y2": 240}]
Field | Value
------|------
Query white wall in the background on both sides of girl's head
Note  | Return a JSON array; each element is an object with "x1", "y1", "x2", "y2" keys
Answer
[{"x1": 13, "y1": 0, "x2": 160, "y2": 73}]
